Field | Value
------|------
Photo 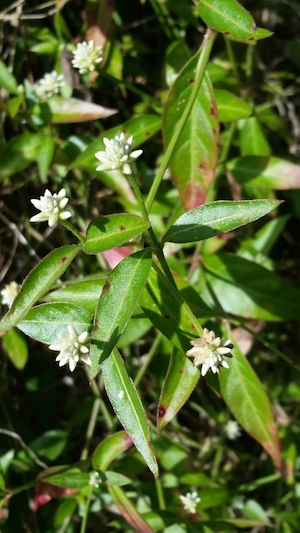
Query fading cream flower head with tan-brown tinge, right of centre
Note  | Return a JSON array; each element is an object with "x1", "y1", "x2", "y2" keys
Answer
[{"x1": 186, "y1": 328, "x2": 233, "y2": 376}]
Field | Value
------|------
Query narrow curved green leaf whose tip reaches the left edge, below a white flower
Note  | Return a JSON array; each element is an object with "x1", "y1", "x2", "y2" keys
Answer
[{"x1": 0, "y1": 245, "x2": 82, "y2": 336}]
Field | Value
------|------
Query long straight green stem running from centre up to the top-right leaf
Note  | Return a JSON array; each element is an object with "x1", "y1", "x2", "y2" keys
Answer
[{"x1": 146, "y1": 28, "x2": 217, "y2": 212}]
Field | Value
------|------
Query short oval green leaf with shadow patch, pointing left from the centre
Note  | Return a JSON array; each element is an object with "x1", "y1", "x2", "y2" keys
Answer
[{"x1": 83, "y1": 214, "x2": 150, "y2": 254}]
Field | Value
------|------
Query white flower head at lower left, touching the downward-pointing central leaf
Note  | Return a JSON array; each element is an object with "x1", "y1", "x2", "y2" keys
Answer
[{"x1": 49, "y1": 325, "x2": 91, "y2": 372}]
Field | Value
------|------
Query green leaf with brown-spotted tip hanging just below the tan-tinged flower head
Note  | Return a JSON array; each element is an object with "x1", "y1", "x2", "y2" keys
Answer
[{"x1": 157, "y1": 348, "x2": 200, "y2": 433}]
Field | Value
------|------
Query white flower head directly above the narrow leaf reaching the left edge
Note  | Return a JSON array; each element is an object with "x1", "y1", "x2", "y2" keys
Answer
[{"x1": 30, "y1": 189, "x2": 72, "y2": 228}]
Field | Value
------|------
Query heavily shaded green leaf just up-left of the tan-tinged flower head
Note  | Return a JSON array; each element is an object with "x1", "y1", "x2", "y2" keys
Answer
[{"x1": 139, "y1": 268, "x2": 203, "y2": 352}]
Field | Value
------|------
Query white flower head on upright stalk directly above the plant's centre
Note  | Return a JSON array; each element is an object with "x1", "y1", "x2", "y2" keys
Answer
[{"x1": 95, "y1": 133, "x2": 143, "y2": 174}]
